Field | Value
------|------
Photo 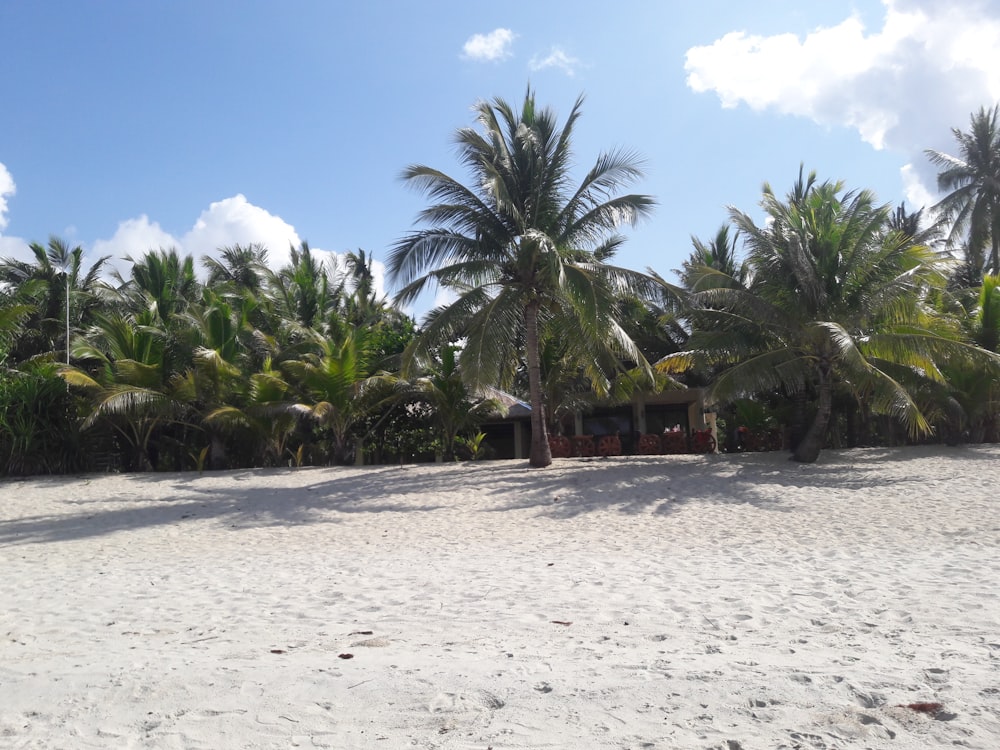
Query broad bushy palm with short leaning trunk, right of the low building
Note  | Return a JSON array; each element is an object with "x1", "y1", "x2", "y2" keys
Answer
[{"x1": 661, "y1": 171, "x2": 1000, "y2": 462}]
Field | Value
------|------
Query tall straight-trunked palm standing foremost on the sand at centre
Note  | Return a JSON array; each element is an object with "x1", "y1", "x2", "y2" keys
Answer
[{"x1": 388, "y1": 88, "x2": 654, "y2": 467}]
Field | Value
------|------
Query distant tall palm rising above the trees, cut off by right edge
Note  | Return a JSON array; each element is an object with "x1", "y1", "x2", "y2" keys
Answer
[{"x1": 926, "y1": 104, "x2": 1000, "y2": 275}]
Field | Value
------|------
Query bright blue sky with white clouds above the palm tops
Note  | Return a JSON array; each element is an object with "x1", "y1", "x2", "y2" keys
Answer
[{"x1": 0, "y1": 0, "x2": 1000, "y2": 313}]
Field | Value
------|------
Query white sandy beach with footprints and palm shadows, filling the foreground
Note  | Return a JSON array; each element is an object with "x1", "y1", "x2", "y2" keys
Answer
[{"x1": 0, "y1": 446, "x2": 1000, "y2": 750}]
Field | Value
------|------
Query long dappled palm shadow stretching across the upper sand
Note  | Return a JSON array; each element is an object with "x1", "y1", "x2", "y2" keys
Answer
[{"x1": 0, "y1": 447, "x2": 997, "y2": 546}]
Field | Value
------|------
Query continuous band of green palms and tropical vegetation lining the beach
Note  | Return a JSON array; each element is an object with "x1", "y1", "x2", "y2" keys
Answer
[{"x1": 0, "y1": 88, "x2": 1000, "y2": 475}]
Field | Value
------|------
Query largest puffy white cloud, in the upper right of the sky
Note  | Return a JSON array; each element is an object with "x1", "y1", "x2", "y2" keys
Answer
[{"x1": 685, "y1": 0, "x2": 1000, "y2": 201}]
